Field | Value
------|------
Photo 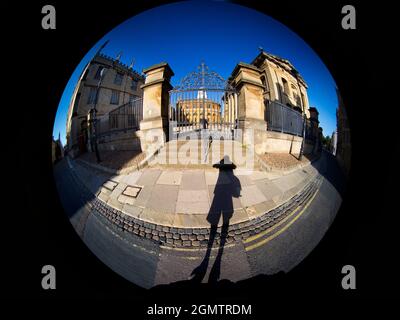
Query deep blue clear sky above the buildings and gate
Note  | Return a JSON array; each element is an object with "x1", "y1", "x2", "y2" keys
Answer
[{"x1": 53, "y1": 1, "x2": 337, "y2": 144}]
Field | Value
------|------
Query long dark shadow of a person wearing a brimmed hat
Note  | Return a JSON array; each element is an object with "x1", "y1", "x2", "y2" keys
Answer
[{"x1": 190, "y1": 155, "x2": 241, "y2": 282}]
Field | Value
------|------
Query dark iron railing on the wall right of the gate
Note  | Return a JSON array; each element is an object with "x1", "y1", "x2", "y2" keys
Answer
[{"x1": 266, "y1": 101, "x2": 304, "y2": 136}]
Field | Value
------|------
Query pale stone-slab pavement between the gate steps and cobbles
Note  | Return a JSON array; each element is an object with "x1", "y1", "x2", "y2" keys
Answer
[{"x1": 69, "y1": 144, "x2": 318, "y2": 245}]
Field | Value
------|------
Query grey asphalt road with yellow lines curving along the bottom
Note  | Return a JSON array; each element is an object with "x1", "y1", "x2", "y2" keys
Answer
[{"x1": 55, "y1": 153, "x2": 344, "y2": 288}]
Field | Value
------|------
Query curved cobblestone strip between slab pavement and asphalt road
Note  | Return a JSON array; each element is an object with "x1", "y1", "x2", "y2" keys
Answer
[{"x1": 66, "y1": 156, "x2": 322, "y2": 248}]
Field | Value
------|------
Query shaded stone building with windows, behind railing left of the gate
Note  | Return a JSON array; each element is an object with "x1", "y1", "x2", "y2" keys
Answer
[{"x1": 66, "y1": 53, "x2": 144, "y2": 156}]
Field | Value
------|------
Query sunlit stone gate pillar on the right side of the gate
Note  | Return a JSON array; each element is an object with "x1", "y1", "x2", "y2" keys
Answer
[{"x1": 231, "y1": 63, "x2": 267, "y2": 154}]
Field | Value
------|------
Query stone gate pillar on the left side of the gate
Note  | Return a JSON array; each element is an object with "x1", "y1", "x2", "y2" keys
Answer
[{"x1": 138, "y1": 62, "x2": 174, "y2": 154}]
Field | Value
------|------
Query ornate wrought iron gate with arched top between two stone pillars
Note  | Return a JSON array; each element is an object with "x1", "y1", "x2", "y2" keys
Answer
[{"x1": 169, "y1": 62, "x2": 238, "y2": 139}]
